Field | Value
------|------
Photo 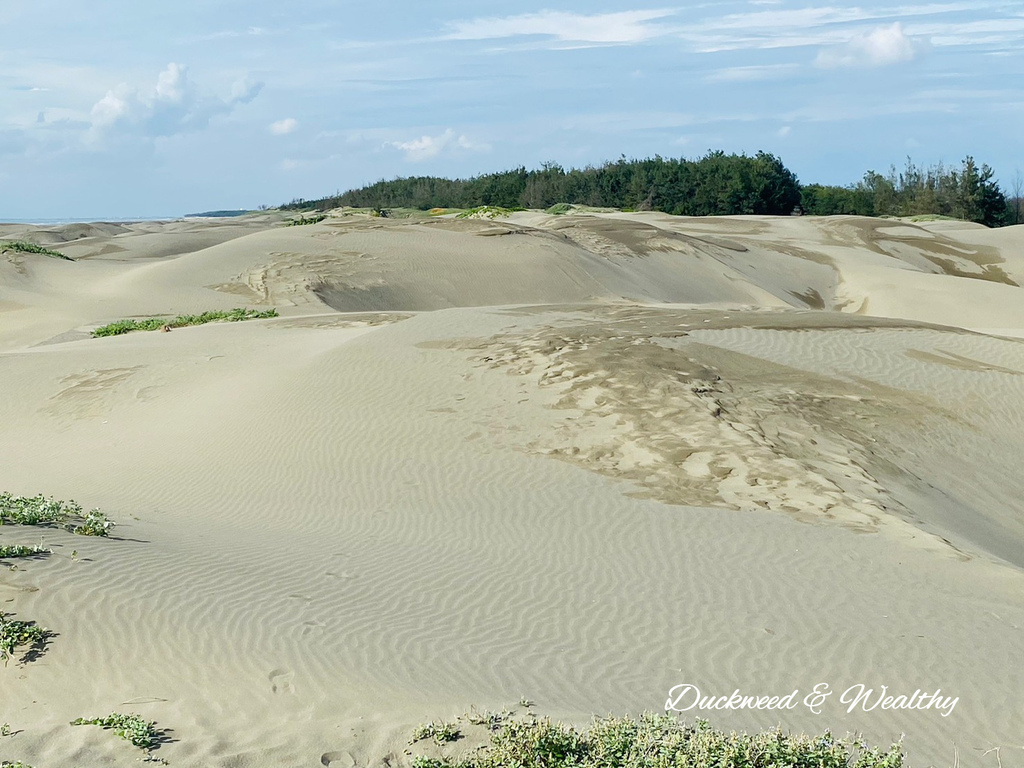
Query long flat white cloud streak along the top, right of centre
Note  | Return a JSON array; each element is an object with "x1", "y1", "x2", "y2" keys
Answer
[{"x1": 449, "y1": 10, "x2": 673, "y2": 44}]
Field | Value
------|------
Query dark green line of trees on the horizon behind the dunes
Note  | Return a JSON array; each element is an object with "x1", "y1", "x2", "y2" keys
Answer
[{"x1": 282, "y1": 152, "x2": 1024, "y2": 226}]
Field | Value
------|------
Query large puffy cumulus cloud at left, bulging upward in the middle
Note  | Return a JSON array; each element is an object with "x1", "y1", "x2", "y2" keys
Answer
[{"x1": 87, "y1": 62, "x2": 263, "y2": 142}]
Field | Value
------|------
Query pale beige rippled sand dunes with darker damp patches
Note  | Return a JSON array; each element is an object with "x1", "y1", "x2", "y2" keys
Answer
[{"x1": 0, "y1": 213, "x2": 1024, "y2": 768}]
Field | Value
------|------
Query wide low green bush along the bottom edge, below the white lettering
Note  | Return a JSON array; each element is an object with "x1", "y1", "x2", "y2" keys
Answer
[{"x1": 414, "y1": 714, "x2": 903, "y2": 768}]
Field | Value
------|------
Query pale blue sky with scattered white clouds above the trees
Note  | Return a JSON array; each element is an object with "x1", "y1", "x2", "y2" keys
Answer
[{"x1": 0, "y1": 0, "x2": 1024, "y2": 220}]
